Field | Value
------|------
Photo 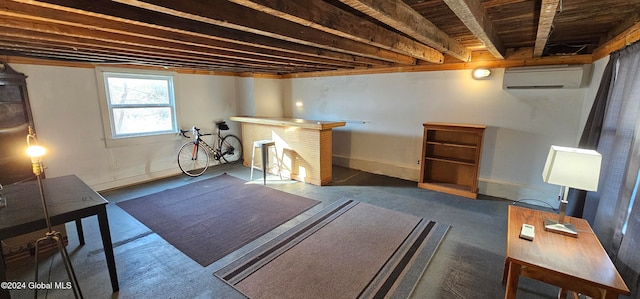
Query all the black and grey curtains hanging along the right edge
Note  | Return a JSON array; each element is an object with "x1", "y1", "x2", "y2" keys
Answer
[{"x1": 569, "y1": 42, "x2": 640, "y2": 298}]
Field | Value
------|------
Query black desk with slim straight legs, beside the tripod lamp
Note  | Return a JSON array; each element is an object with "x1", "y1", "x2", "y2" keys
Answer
[{"x1": 0, "y1": 175, "x2": 120, "y2": 298}]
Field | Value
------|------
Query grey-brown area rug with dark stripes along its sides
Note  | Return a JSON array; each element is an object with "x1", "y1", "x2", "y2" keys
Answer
[{"x1": 214, "y1": 199, "x2": 449, "y2": 298}]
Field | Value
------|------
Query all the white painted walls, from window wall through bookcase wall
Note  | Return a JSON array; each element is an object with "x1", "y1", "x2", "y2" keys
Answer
[{"x1": 12, "y1": 59, "x2": 606, "y2": 209}]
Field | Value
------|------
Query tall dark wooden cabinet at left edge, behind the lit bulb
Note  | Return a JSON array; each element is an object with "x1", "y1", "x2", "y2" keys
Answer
[{"x1": 0, "y1": 62, "x2": 35, "y2": 185}]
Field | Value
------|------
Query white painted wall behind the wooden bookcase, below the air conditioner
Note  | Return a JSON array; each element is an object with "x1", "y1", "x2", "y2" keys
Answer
[{"x1": 284, "y1": 62, "x2": 602, "y2": 206}]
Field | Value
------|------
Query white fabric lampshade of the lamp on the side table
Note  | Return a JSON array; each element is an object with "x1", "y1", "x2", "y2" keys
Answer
[{"x1": 542, "y1": 145, "x2": 602, "y2": 191}]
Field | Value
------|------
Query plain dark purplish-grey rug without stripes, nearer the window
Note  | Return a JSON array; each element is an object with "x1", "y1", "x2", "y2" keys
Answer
[{"x1": 117, "y1": 174, "x2": 320, "y2": 266}]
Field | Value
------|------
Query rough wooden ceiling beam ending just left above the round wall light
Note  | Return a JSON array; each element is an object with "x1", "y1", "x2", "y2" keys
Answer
[{"x1": 339, "y1": 0, "x2": 471, "y2": 61}]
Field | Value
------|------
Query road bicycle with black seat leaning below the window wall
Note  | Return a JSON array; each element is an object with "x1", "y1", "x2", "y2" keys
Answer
[{"x1": 178, "y1": 121, "x2": 242, "y2": 177}]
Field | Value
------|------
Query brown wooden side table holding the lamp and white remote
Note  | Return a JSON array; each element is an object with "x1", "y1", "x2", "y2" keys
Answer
[{"x1": 503, "y1": 206, "x2": 630, "y2": 298}]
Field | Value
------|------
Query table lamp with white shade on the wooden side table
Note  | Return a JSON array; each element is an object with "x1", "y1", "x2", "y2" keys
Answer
[{"x1": 542, "y1": 145, "x2": 602, "y2": 237}]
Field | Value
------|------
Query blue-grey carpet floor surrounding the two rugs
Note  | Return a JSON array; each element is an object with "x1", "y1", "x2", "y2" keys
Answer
[{"x1": 3, "y1": 165, "x2": 558, "y2": 299}]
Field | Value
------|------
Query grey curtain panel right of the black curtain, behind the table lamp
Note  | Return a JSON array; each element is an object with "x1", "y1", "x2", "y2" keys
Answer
[{"x1": 585, "y1": 43, "x2": 640, "y2": 259}]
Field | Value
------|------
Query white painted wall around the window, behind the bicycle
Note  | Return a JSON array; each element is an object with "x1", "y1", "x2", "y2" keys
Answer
[{"x1": 11, "y1": 64, "x2": 240, "y2": 190}]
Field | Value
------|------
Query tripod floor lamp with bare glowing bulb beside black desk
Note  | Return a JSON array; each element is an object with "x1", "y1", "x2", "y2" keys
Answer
[{"x1": 27, "y1": 127, "x2": 82, "y2": 298}]
